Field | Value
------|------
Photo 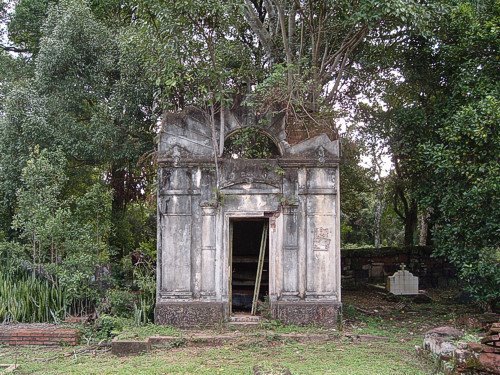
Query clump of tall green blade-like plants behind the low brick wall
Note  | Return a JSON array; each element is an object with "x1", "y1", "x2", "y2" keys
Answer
[{"x1": 0, "y1": 272, "x2": 70, "y2": 323}]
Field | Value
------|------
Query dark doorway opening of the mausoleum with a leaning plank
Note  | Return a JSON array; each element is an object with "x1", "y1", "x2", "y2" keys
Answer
[{"x1": 231, "y1": 218, "x2": 269, "y2": 315}]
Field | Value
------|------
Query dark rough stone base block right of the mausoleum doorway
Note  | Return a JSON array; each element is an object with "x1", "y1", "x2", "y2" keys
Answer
[{"x1": 271, "y1": 301, "x2": 342, "y2": 327}]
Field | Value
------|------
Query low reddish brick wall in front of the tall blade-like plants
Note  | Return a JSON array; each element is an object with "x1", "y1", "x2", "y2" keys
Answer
[{"x1": 0, "y1": 324, "x2": 80, "y2": 345}]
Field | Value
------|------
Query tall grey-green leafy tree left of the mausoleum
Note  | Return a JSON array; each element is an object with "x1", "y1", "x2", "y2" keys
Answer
[{"x1": 0, "y1": 0, "x2": 156, "y2": 262}]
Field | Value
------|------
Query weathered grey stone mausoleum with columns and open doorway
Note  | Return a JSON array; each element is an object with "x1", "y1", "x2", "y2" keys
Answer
[{"x1": 155, "y1": 110, "x2": 341, "y2": 327}]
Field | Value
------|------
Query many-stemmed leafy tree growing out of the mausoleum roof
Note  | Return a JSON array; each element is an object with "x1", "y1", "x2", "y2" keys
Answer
[{"x1": 136, "y1": 0, "x2": 438, "y2": 123}]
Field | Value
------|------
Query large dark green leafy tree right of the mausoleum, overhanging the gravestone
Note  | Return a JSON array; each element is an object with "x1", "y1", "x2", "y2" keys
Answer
[{"x1": 365, "y1": 1, "x2": 500, "y2": 304}]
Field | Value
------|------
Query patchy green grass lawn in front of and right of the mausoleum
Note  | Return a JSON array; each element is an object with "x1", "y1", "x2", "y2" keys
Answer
[{"x1": 0, "y1": 292, "x2": 482, "y2": 375}]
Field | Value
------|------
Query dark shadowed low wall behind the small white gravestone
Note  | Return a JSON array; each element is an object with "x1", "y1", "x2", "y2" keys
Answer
[{"x1": 341, "y1": 246, "x2": 456, "y2": 288}]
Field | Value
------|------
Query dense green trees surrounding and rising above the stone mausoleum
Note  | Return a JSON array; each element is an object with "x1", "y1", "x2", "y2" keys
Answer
[{"x1": 0, "y1": 0, "x2": 500, "y2": 320}]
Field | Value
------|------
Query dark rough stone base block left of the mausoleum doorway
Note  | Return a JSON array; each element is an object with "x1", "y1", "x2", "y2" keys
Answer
[{"x1": 155, "y1": 301, "x2": 227, "y2": 328}]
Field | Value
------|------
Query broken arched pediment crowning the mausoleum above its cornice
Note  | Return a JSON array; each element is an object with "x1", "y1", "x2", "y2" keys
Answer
[{"x1": 158, "y1": 108, "x2": 339, "y2": 163}]
